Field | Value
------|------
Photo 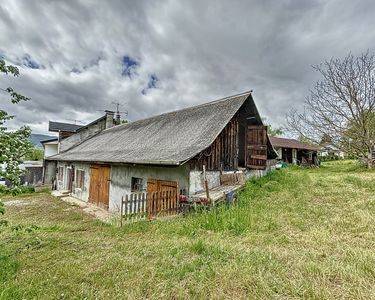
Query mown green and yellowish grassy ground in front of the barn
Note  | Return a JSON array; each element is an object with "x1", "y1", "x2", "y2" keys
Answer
[{"x1": 0, "y1": 163, "x2": 375, "y2": 299}]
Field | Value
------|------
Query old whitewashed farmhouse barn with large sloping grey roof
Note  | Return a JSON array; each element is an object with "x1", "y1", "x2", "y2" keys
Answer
[{"x1": 46, "y1": 92, "x2": 277, "y2": 212}]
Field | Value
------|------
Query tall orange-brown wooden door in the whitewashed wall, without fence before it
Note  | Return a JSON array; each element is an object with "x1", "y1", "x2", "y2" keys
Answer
[{"x1": 89, "y1": 165, "x2": 110, "y2": 209}]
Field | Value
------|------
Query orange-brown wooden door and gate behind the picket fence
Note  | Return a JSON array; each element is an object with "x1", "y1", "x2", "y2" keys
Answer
[{"x1": 147, "y1": 179, "x2": 179, "y2": 218}]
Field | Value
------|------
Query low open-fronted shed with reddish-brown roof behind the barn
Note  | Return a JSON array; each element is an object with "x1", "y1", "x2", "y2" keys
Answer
[{"x1": 270, "y1": 137, "x2": 319, "y2": 165}]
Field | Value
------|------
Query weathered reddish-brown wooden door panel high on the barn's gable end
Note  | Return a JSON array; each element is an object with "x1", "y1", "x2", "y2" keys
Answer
[{"x1": 246, "y1": 125, "x2": 267, "y2": 169}]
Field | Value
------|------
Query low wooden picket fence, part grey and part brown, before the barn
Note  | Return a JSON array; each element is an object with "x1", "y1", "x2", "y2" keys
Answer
[{"x1": 120, "y1": 190, "x2": 179, "y2": 226}]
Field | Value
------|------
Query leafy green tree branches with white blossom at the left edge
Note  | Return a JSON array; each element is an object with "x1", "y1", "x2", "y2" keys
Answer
[{"x1": 0, "y1": 59, "x2": 33, "y2": 186}]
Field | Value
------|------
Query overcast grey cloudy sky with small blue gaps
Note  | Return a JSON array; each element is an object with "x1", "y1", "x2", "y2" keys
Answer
[{"x1": 0, "y1": 0, "x2": 375, "y2": 133}]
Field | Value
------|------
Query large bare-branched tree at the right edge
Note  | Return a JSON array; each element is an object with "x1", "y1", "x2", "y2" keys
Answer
[{"x1": 287, "y1": 52, "x2": 375, "y2": 167}]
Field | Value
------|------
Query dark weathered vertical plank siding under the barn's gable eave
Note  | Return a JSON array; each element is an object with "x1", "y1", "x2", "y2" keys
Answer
[{"x1": 190, "y1": 114, "x2": 239, "y2": 170}]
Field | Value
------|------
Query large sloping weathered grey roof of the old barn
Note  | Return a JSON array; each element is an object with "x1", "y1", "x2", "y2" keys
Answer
[{"x1": 48, "y1": 92, "x2": 268, "y2": 165}]
